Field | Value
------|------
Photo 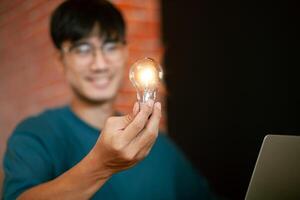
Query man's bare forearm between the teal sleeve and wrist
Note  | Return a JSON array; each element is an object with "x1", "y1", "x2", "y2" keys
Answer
[{"x1": 18, "y1": 151, "x2": 110, "y2": 200}]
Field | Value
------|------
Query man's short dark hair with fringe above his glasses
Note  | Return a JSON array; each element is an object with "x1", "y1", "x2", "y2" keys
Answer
[{"x1": 50, "y1": 0, "x2": 126, "y2": 49}]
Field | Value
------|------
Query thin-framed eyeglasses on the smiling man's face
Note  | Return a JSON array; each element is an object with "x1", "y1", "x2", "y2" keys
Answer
[{"x1": 65, "y1": 42, "x2": 124, "y2": 64}]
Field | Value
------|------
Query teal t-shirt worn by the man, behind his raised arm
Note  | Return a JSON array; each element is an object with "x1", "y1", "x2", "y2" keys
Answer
[{"x1": 3, "y1": 106, "x2": 212, "y2": 200}]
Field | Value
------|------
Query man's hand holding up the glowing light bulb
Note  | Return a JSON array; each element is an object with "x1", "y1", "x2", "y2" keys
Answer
[{"x1": 97, "y1": 101, "x2": 161, "y2": 171}]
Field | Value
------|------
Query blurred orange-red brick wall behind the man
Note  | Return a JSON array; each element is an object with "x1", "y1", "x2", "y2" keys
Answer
[{"x1": 0, "y1": 0, "x2": 165, "y2": 165}]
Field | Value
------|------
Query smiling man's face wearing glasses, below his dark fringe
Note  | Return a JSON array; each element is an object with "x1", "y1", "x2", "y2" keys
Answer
[{"x1": 62, "y1": 36, "x2": 127, "y2": 103}]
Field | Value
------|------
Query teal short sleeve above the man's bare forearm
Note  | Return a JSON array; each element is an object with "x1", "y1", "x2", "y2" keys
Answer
[{"x1": 3, "y1": 131, "x2": 53, "y2": 199}]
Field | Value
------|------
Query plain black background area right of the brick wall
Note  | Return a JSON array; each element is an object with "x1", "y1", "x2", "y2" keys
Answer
[{"x1": 162, "y1": 0, "x2": 300, "y2": 199}]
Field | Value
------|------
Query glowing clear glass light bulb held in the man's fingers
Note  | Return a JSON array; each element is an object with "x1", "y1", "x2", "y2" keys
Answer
[{"x1": 129, "y1": 58, "x2": 163, "y2": 103}]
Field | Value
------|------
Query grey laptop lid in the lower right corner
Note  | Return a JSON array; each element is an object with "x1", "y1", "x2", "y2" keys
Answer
[{"x1": 245, "y1": 135, "x2": 300, "y2": 200}]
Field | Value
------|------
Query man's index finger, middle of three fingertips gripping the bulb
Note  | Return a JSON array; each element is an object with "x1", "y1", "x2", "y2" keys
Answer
[{"x1": 124, "y1": 100, "x2": 154, "y2": 143}]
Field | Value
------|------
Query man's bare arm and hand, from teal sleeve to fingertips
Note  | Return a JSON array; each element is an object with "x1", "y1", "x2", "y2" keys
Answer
[{"x1": 18, "y1": 101, "x2": 161, "y2": 200}]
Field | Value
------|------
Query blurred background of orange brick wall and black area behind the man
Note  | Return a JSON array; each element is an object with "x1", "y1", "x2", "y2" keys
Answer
[{"x1": 0, "y1": 0, "x2": 300, "y2": 199}]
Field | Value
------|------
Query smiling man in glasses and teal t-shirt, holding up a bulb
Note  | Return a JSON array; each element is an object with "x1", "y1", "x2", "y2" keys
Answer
[{"x1": 3, "y1": 0, "x2": 211, "y2": 200}]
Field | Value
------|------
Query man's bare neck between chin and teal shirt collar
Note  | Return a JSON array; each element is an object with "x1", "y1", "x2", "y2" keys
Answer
[{"x1": 71, "y1": 98, "x2": 114, "y2": 129}]
